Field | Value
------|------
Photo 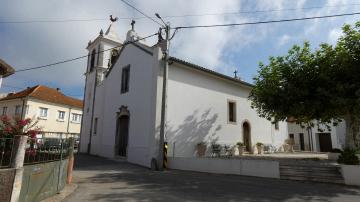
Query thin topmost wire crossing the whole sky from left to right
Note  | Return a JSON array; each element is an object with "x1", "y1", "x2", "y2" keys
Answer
[{"x1": 0, "y1": 3, "x2": 360, "y2": 24}]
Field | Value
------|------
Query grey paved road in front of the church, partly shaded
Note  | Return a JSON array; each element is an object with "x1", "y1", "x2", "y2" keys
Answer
[{"x1": 65, "y1": 155, "x2": 360, "y2": 202}]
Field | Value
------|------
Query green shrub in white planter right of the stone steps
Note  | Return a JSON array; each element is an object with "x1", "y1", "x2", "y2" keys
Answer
[{"x1": 338, "y1": 149, "x2": 360, "y2": 186}]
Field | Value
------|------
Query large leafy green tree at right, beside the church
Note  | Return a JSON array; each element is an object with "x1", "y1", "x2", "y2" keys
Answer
[{"x1": 249, "y1": 22, "x2": 360, "y2": 148}]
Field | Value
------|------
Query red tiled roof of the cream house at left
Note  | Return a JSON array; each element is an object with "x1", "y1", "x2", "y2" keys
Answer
[{"x1": 0, "y1": 85, "x2": 83, "y2": 109}]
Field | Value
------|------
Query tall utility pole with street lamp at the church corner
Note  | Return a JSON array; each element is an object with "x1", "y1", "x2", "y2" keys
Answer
[{"x1": 155, "y1": 14, "x2": 170, "y2": 170}]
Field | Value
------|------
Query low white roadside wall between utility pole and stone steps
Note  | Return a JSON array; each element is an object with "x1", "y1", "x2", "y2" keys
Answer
[{"x1": 168, "y1": 157, "x2": 280, "y2": 179}]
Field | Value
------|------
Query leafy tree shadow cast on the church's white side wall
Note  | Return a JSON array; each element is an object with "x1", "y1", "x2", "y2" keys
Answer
[{"x1": 166, "y1": 108, "x2": 221, "y2": 157}]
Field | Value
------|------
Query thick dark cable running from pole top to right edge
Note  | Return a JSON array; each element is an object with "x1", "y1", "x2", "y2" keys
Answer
[{"x1": 172, "y1": 12, "x2": 360, "y2": 29}]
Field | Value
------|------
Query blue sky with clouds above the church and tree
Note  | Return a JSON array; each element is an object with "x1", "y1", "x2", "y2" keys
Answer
[{"x1": 0, "y1": 0, "x2": 360, "y2": 97}]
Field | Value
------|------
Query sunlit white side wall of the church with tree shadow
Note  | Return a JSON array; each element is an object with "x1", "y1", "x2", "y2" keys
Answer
[{"x1": 166, "y1": 64, "x2": 287, "y2": 157}]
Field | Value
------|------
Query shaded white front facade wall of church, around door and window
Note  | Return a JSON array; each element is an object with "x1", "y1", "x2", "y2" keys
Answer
[{"x1": 91, "y1": 45, "x2": 158, "y2": 166}]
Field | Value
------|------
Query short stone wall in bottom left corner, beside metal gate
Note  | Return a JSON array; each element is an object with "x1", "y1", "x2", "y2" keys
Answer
[{"x1": 0, "y1": 168, "x2": 15, "y2": 201}]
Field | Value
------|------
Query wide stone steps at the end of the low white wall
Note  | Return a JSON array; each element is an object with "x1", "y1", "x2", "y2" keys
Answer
[{"x1": 280, "y1": 162, "x2": 344, "y2": 184}]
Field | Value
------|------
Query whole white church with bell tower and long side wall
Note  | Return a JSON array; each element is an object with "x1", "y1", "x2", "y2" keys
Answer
[{"x1": 80, "y1": 22, "x2": 344, "y2": 167}]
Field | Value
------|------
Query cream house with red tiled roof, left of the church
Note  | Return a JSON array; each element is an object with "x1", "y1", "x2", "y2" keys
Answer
[{"x1": 0, "y1": 85, "x2": 83, "y2": 133}]
